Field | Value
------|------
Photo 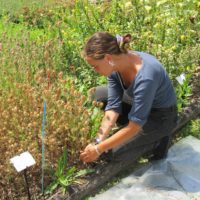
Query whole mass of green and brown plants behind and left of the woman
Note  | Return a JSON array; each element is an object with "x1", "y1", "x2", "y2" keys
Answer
[{"x1": 0, "y1": 0, "x2": 200, "y2": 198}]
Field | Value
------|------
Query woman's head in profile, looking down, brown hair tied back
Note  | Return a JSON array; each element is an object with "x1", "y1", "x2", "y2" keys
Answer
[{"x1": 83, "y1": 32, "x2": 131, "y2": 76}]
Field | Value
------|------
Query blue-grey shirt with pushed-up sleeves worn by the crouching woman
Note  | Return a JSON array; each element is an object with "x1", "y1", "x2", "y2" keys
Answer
[{"x1": 105, "y1": 52, "x2": 176, "y2": 126}]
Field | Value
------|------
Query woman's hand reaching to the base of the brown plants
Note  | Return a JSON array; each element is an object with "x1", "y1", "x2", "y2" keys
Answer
[{"x1": 80, "y1": 144, "x2": 99, "y2": 163}]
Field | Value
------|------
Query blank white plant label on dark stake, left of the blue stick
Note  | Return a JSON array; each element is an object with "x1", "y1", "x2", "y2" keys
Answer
[{"x1": 10, "y1": 151, "x2": 35, "y2": 172}]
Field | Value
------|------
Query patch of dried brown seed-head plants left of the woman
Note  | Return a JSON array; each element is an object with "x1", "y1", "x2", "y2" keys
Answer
[{"x1": 0, "y1": 69, "x2": 103, "y2": 195}]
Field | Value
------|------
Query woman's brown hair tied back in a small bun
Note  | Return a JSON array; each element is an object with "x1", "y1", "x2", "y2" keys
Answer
[{"x1": 83, "y1": 32, "x2": 131, "y2": 59}]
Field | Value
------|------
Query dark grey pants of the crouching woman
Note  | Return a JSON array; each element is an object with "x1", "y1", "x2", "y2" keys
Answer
[{"x1": 93, "y1": 86, "x2": 177, "y2": 159}]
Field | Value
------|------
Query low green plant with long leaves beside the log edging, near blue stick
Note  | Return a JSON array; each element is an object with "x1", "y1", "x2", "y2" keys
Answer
[{"x1": 45, "y1": 149, "x2": 94, "y2": 194}]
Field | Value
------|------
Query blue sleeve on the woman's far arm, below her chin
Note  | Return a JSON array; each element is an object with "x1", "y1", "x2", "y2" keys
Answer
[{"x1": 105, "y1": 74, "x2": 123, "y2": 114}]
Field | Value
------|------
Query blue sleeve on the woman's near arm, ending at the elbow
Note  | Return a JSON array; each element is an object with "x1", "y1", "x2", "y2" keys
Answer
[{"x1": 128, "y1": 79, "x2": 157, "y2": 126}]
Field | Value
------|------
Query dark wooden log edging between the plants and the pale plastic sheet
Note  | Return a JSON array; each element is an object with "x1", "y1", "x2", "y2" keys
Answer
[{"x1": 48, "y1": 69, "x2": 200, "y2": 200}]
